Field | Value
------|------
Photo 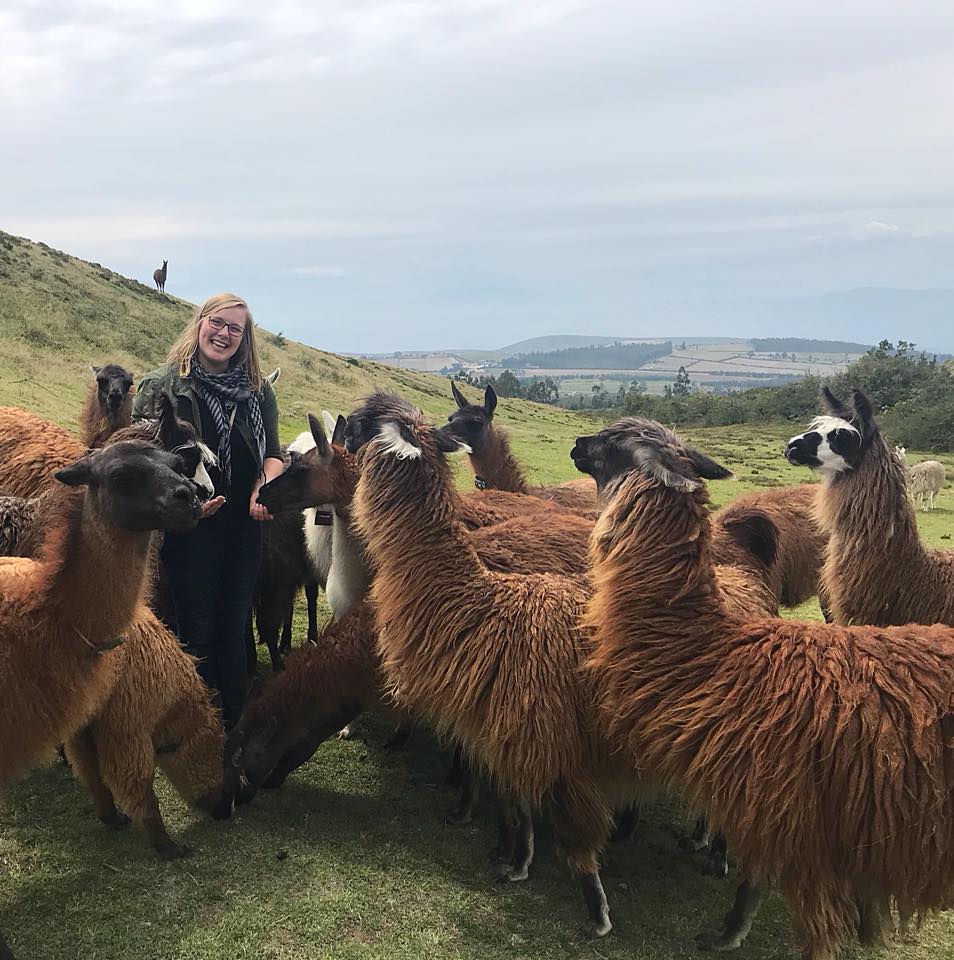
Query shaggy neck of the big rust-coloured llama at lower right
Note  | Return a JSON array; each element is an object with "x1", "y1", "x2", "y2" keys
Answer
[{"x1": 590, "y1": 473, "x2": 724, "y2": 628}]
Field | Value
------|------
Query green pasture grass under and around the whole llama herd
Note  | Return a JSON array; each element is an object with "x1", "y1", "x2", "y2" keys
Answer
[{"x1": 0, "y1": 236, "x2": 954, "y2": 960}]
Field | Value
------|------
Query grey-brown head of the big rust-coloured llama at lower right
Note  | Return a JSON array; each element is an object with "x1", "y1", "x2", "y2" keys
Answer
[{"x1": 570, "y1": 417, "x2": 732, "y2": 492}]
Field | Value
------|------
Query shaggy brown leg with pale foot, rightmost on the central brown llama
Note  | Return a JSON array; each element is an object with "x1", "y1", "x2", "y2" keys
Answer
[{"x1": 550, "y1": 780, "x2": 613, "y2": 939}]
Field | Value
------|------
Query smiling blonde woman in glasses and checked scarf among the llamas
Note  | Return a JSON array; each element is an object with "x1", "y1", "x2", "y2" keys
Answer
[{"x1": 133, "y1": 293, "x2": 283, "y2": 729}]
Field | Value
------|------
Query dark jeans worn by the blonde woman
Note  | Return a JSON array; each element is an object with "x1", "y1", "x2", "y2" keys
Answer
[{"x1": 162, "y1": 505, "x2": 262, "y2": 730}]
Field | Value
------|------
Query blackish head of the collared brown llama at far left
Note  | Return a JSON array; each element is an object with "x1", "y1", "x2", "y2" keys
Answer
[{"x1": 53, "y1": 440, "x2": 202, "y2": 532}]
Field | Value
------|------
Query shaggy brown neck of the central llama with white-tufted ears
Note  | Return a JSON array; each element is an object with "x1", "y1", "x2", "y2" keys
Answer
[{"x1": 353, "y1": 451, "x2": 487, "y2": 589}]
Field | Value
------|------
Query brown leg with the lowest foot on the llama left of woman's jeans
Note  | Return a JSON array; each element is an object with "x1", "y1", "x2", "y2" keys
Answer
[{"x1": 96, "y1": 728, "x2": 192, "y2": 860}]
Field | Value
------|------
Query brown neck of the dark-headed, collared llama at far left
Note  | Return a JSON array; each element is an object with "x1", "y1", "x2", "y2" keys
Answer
[{"x1": 44, "y1": 492, "x2": 152, "y2": 645}]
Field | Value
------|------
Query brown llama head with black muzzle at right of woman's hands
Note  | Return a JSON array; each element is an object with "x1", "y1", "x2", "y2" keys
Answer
[{"x1": 258, "y1": 414, "x2": 350, "y2": 513}]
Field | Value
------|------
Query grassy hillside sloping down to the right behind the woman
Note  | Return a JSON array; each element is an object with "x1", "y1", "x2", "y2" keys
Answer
[{"x1": 0, "y1": 232, "x2": 592, "y2": 482}]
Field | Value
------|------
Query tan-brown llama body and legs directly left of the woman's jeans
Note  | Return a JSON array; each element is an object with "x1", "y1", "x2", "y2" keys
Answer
[{"x1": 66, "y1": 606, "x2": 232, "y2": 860}]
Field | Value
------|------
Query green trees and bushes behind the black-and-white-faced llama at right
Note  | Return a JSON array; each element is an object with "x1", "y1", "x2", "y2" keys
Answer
[{"x1": 611, "y1": 340, "x2": 954, "y2": 451}]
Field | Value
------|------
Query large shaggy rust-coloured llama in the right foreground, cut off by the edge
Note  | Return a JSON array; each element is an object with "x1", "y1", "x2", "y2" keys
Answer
[{"x1": 576, "y1": 417, "x2": 954, "y2": 960}]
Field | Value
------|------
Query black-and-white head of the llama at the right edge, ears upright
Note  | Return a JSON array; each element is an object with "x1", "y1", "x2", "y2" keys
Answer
[{"x1": 785, "y1": 387, "x2": 879, "y2": 476}]
